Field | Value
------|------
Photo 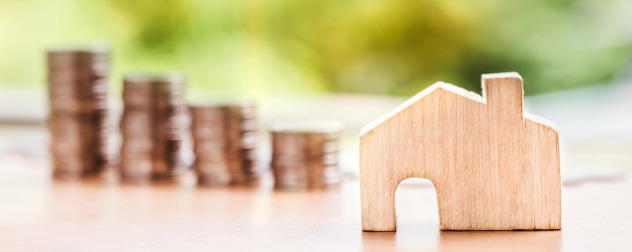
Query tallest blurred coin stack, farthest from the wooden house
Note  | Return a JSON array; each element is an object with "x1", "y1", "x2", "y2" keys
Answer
[{"x1": 47, "y1": 48, "x2": 113, "y2": 178}]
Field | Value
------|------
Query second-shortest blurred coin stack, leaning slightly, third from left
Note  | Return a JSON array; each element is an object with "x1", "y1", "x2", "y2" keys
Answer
[{"x1": 190, "y1": 99, "x2": 261, "y2": 186}]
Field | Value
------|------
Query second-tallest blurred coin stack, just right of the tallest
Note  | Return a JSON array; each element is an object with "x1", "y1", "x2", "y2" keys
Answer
[{"x1": 120, "y1": 73, "x2": 189, "y2": 182}]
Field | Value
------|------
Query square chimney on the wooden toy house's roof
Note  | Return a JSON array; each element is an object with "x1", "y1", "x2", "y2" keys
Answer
[{"x1": 483, "y1": 72, "x2": 524, "y2": 120}]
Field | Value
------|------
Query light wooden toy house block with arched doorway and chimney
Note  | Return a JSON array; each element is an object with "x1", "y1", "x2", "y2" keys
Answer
[{"x1": 360, "y1": 73, "x2": 561, "y2": 231}]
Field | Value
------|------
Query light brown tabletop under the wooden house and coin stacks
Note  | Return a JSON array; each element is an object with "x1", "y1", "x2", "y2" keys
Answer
[{"x1": 0, "y1": 156, "x2": 632, "y2": 251}]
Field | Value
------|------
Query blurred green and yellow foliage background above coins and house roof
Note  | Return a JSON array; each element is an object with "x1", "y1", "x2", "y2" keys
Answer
[{"x1": 0, "y1": 0, "x2": 632, "y2": 95}]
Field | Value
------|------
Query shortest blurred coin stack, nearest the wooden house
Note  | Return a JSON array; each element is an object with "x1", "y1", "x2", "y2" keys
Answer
[{"x1": 270, "y1": 121, "x2": 342, "y2": 190}]
